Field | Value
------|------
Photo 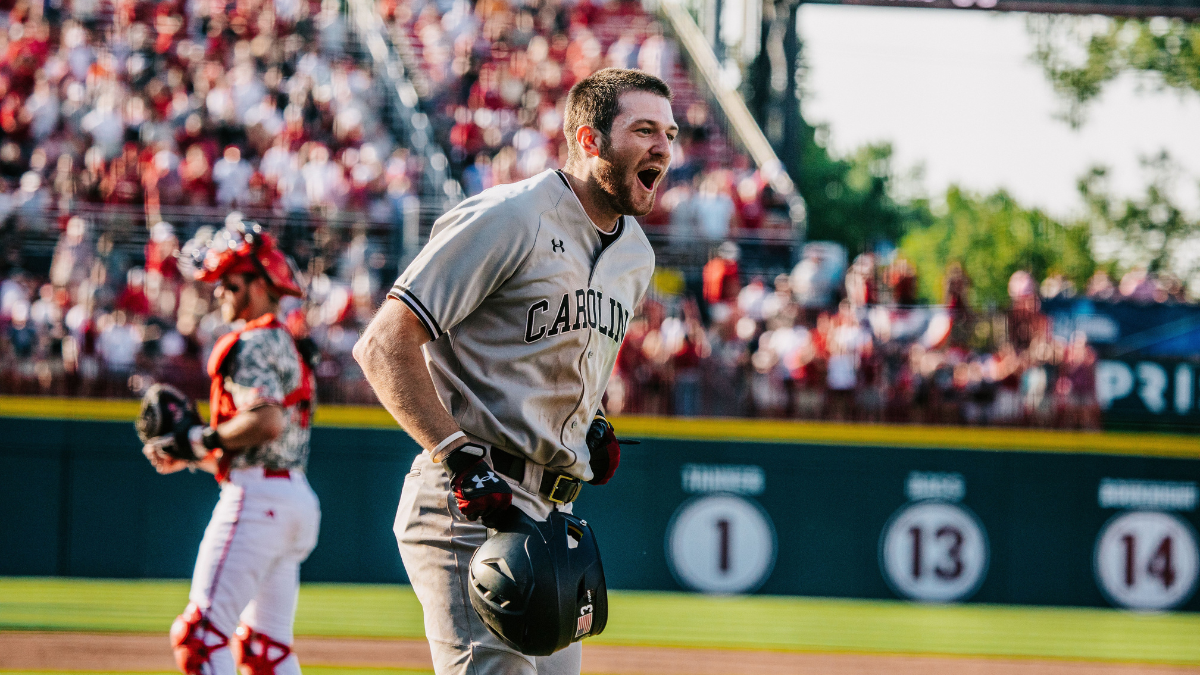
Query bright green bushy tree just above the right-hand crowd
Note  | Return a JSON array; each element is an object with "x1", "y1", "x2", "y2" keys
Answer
[{"x1": 900, "y1": 186, "x2": 1096, "y2": 306}]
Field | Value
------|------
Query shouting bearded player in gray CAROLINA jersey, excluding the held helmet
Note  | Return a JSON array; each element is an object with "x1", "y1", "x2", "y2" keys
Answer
[{"x1": 354, "y1": 68, "x2": 678, "y2": 675}]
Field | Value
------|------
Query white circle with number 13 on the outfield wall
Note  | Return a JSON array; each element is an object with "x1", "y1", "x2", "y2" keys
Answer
[{"x1": 880, "y1": 501, "x2": 989, "y2": 603}]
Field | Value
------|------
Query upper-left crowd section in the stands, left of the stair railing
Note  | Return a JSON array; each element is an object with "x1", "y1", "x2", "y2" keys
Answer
[{"x1": 0, "y1": 0, "x2": 420, "y2": 229}]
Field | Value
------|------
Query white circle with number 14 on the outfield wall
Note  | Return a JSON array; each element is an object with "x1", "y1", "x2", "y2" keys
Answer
[{"x1": 1094, "y1": 510, "x2": 1200, "y2": 610}]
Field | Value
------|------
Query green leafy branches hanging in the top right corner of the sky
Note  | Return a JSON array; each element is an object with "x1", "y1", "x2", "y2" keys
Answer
[{"x1": 1026, "y1": 14, "x2": 1200, "y2": 129}]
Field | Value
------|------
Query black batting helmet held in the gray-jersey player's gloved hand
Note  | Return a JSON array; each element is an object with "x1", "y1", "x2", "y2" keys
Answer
[{"x1": 470, "y1": 507, "x2": 608, "y2": 656}]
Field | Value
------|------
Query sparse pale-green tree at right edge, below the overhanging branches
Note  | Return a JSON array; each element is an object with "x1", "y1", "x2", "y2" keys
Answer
[{"x1": 1079, "y1": 151, "x2": 1200, "y2": 288}]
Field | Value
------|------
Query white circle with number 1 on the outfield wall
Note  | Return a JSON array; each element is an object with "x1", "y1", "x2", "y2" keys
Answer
[{"x1": 666, "y1": 494, "x2": 776, "y2": 595}]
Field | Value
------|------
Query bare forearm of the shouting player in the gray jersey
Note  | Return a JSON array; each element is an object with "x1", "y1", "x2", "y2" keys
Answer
[{"x1": 354, "y1": 299, "x2": 466, "y2": 449}]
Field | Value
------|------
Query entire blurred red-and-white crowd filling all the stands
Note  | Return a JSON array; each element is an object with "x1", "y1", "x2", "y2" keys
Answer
[{"x1": 0, "y1": 0, "x2": 1178, "y2": 428}]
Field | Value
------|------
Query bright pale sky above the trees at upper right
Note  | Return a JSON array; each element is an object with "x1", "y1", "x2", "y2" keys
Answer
[{"x1": 799, "y1": 5, "x2": 1200, "y2": 217}]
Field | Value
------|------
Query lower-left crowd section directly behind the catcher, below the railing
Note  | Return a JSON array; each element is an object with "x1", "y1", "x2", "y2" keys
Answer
[{"x1": 0, "y1": 214, "x2": 385, "y2": 404}]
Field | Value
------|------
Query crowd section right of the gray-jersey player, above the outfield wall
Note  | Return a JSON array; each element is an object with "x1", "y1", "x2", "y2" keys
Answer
[{"x1": 608, "y1": 243, "x2": 1180, "y2": 429}]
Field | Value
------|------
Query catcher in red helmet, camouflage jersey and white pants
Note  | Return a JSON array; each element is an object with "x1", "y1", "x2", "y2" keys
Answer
[{"x1": 138, "y1": 215, "x2": 320, "y2": 675}]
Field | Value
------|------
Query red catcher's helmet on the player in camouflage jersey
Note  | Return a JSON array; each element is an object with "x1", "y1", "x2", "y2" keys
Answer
[{"x1": 187, "y1": 217, "x2": 304, "y2": 297}]
